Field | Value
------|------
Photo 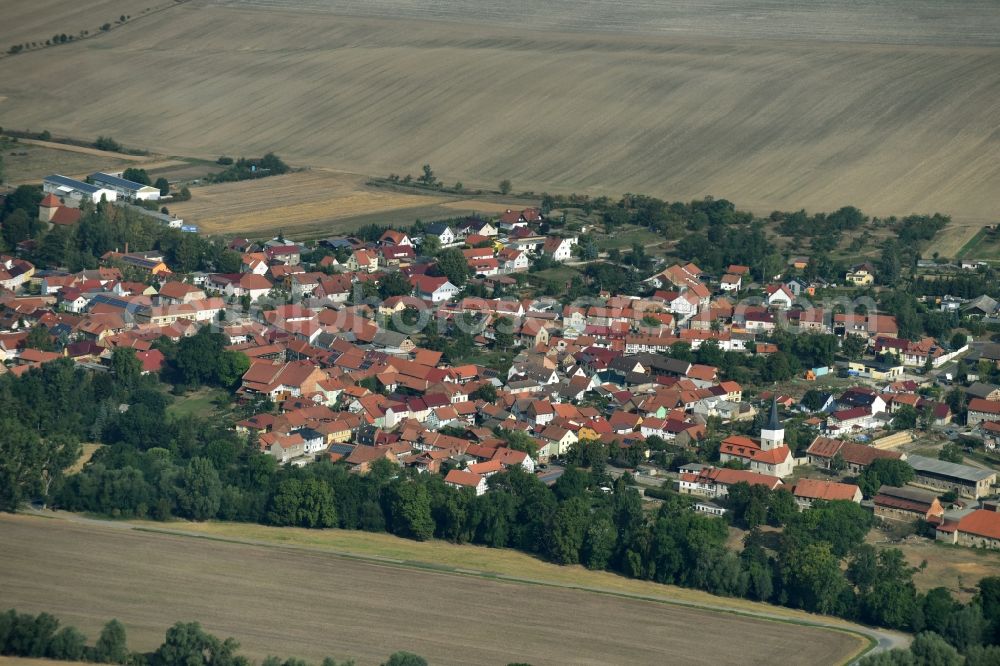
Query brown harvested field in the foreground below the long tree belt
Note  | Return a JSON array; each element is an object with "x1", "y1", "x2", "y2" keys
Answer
[{"x1": 0, "y1": 515, "x2": 863, "y2": 666}]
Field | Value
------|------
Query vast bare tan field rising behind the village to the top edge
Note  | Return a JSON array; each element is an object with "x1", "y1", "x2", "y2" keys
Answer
[{"x1": 0, "y1": 0, "x2": 1000, "y2": 227}]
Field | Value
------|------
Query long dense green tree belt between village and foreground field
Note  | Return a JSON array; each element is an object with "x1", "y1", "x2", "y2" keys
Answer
[{"x1": 0, "y1": 361, "x2": 998, "y2": 646}]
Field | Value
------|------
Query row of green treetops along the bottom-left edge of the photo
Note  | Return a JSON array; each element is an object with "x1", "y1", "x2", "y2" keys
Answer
[{"x1": 0, "y1": 609, "x2": 427, "y2": 666}]
